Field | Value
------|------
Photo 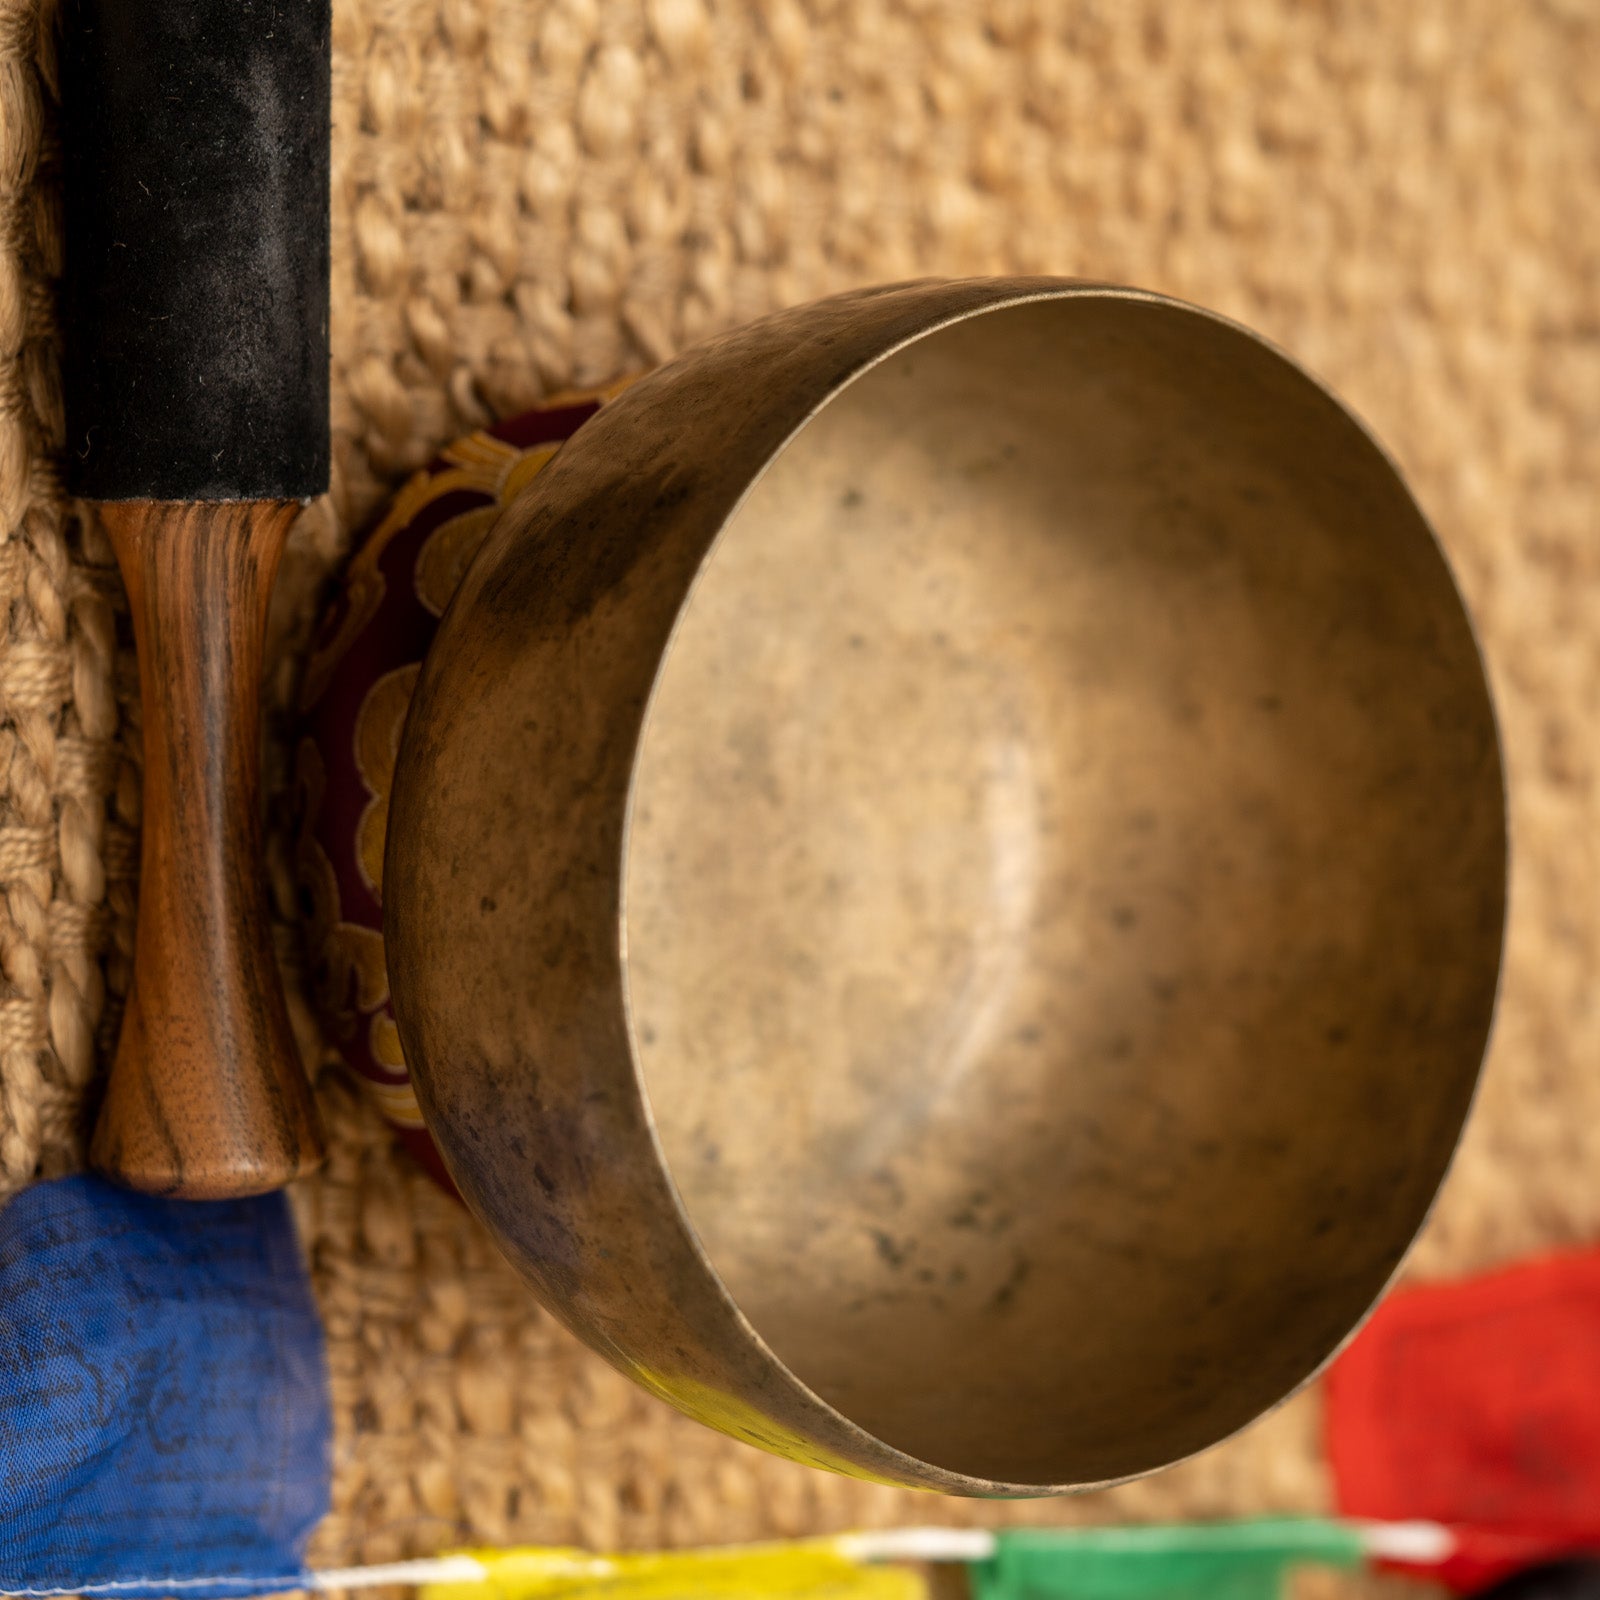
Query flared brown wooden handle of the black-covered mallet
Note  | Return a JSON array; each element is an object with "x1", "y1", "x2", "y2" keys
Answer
[{"x1": 91, "y1": 501, "x2": 322, "y2": 1200}]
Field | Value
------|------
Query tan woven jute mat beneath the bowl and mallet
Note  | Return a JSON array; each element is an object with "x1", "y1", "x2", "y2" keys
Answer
[{"x1": 0, "y1": 0, "x2": 1600, "y2": 1560}]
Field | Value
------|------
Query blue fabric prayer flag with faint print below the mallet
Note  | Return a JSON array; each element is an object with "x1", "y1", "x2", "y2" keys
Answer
[{"x1": 0, "y1": 1176, "x2": 331, "y2": 1600}]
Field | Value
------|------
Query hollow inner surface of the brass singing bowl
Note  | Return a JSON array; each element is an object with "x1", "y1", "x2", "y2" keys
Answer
[{"x1": 626, "y1": 296, "x2": 1504, "y2": 1485}]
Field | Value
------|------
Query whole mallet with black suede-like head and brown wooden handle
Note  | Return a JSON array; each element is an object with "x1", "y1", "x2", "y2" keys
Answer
[{"x1": 61, "y1": 0, "x2": 330, "y2": 1198}]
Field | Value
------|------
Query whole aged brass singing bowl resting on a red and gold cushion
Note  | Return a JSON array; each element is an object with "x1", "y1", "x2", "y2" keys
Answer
[{"x1": 384, "y1": 280, "x2": 1506, "y2": 1494}]
